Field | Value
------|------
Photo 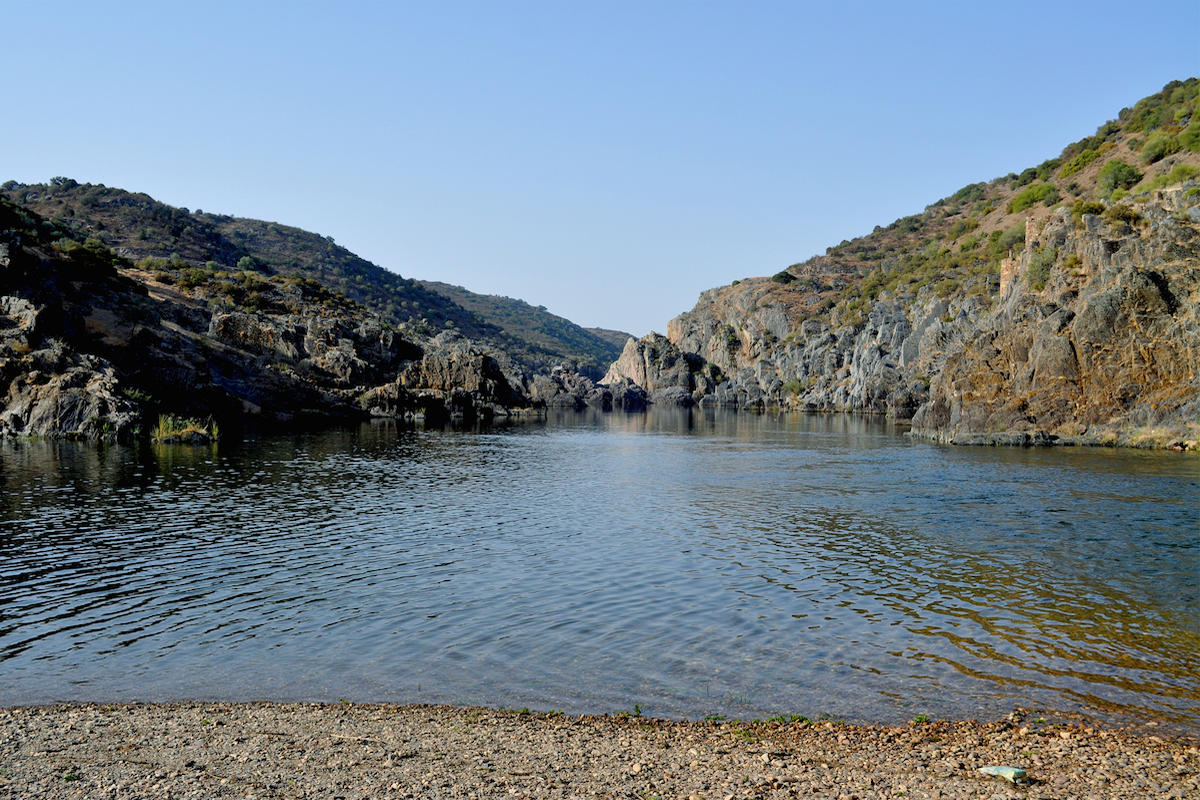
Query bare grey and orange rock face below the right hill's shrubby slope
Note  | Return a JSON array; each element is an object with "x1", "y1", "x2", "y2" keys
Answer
[{"x1": 606, "y1": 185, "x2": 1200, "y2": 445}]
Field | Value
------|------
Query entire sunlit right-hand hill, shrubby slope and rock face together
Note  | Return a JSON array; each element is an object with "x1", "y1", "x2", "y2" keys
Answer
[{"x1": 605, "y1": 78, "x2": 1200, "y2": 446}]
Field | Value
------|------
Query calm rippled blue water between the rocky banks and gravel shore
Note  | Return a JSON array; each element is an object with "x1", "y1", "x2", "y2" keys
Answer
[{"x1": 0, "y1": 410, "x2": 1200, "y2": 730}]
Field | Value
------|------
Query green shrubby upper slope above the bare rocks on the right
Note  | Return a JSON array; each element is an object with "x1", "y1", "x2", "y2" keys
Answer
[{"x1": 770, "y1": 78, "x2": 1200, "y2": 324}]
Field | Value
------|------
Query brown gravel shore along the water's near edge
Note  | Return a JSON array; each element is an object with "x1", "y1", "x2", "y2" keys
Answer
[{"x1": 0, "y1": 703, "x2": 1200, "y2": 800}]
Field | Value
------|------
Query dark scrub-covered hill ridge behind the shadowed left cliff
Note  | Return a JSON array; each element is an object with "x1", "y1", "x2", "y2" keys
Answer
[{"x1": 0, "y1": 178, "x2": 624, "y2": 377}]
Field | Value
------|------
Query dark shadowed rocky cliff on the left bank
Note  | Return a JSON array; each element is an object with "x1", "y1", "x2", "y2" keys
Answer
[{"x1": 0, "y1": 200, "x2": 530, "y2": 439}]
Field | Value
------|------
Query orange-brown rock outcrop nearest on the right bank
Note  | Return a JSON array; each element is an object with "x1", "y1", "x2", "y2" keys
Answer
[{"x1": 913, "y1": 192, "x2": 1200, "y2": 445}]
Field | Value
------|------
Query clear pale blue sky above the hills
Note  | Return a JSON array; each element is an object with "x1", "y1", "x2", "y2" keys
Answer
[{"x1": 0, "y1": 0, "x2": 1200, "y2": 335}]
